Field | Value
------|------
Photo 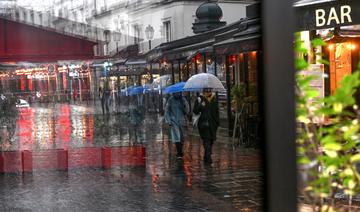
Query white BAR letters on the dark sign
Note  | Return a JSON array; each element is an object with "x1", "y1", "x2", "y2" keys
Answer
[{"x1": 315, "y1": 5, "x2": 352, "y2": 27}]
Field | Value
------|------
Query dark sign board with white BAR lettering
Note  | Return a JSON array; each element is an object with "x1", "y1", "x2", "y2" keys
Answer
[{"x1": 295, "y1": 0, "x2": 360, "y2": 31}]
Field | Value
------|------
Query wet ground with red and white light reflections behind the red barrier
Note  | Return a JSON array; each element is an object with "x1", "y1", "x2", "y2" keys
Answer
[{"x1": 3, "y1": 101, "x2": 162, "y2": 150}]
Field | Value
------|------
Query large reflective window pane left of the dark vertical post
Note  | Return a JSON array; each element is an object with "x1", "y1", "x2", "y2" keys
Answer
[{"x1": 0, "y1": 0, "x2": 264, "y2": 211}]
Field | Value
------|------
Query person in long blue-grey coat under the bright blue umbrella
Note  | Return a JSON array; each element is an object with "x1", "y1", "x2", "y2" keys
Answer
[{"x1": 164, "y1": 93, "x2": 189, "y2": 158}]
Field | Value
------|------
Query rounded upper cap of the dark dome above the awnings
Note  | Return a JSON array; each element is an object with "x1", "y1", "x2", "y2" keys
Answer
[{"x1": 196, "y1": 1, "x2": 223, "y2": 20}]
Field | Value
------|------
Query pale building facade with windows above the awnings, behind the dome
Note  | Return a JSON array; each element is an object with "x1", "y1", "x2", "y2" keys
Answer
[{"x1": 3, "y1": 0, "x2": 254, "y2": 56}]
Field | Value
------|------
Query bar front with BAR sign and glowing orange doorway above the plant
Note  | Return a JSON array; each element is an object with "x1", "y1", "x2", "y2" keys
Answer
[{"x1": 295, "y1": 0, "x2": 360, "y2": 101}]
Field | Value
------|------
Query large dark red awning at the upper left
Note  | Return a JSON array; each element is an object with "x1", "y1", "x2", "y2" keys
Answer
[{"x1": 0, "y1": 18, "x2": 96, "y2": 62}]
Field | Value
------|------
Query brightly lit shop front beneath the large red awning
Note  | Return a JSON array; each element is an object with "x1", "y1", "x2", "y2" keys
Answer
[{"x1": 0, "y1": 62, "x2": 91, "y2": 102}]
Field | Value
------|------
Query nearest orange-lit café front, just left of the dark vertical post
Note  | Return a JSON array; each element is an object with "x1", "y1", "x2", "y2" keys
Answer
[{"x1": 214, "y1": 17, "x2": 262, "y2": 137}]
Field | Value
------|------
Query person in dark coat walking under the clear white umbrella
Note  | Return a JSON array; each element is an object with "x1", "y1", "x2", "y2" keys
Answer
[{"x1": 193, "y1": 88, "x2": 219, "y2": 163}]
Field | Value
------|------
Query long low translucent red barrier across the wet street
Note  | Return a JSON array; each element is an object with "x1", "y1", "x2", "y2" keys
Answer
[{"x1": 0, "y1": 146, "x2": 146, "y2": 173}]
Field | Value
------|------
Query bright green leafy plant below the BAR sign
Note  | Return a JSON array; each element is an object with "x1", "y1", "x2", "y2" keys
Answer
[{"x1": 296, "y1": 37, "x2": 360, "y2": 211}]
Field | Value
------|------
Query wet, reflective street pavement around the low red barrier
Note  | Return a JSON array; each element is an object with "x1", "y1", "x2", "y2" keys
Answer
[{"x1": 0, "y1": 104, "x2": 263, "y2": 211}]
